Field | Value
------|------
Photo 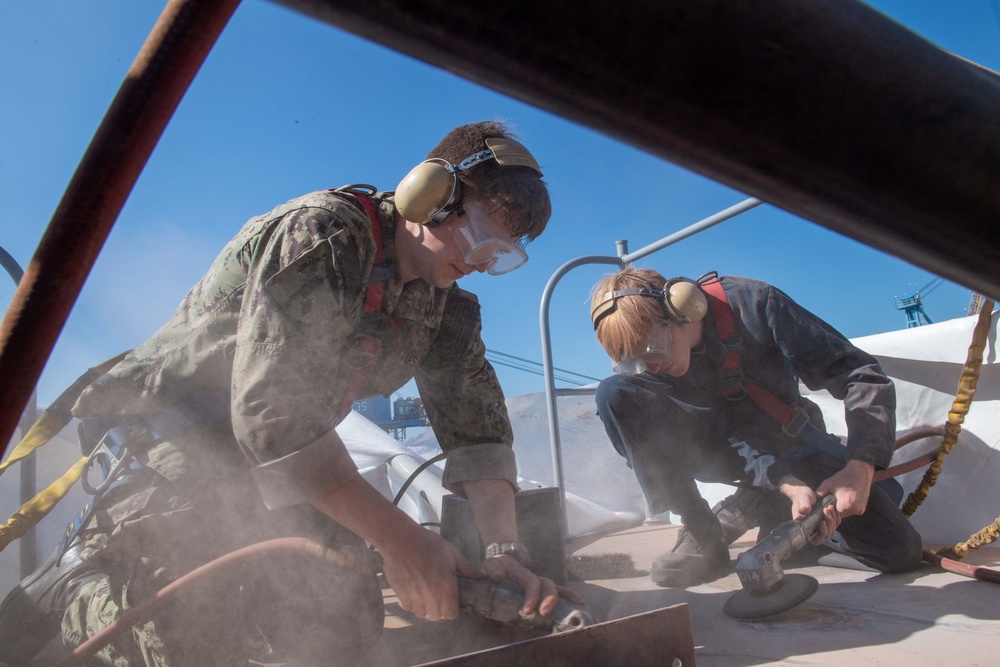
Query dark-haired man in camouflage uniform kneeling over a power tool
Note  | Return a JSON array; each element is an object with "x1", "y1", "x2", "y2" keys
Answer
[{"x1": 0, "y1": 122, "x2": 573, "y2": 666}]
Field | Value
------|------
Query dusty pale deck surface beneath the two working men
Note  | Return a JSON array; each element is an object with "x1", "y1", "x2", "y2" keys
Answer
[{"x1": 383, "y1": 524, "x2": 1000, "y2": 667}]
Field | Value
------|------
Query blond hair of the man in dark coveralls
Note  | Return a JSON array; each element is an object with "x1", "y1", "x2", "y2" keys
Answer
[{"x1": 590, "y1": 264, "x2": 667, "y2": 363}]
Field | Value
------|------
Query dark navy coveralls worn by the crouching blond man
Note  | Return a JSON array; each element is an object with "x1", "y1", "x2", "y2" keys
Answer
[{"x1": 596, "y1": 276, "x2": 922, "y2": 572}]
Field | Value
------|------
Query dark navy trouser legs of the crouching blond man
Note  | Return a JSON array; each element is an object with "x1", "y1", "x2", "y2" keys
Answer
[{"x1": 596, "y1": 373, "x2": 922, "y2": 572}]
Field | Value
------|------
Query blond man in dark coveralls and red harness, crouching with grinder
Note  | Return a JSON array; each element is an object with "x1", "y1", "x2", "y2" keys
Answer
[{"x1": 591, "y1": 266, "x2": 921, "y2": 587}]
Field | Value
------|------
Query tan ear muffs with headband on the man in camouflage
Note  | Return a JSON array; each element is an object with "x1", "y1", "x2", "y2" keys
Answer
[{"x1": 395, "y1": 138, "x2": 542, "y2": 225}]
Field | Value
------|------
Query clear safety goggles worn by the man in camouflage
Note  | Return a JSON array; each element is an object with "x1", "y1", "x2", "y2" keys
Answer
[{"x1": 451, "y1": 202, "x2": 528, "y2": 276}]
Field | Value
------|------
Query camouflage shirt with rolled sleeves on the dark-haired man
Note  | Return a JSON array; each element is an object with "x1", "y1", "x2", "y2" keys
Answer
[{"x1": 74, "y1": 191, "x2": 516, "y2": 507}]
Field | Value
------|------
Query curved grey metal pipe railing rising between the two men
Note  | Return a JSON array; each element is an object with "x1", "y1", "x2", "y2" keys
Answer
[{"x1": 538, "y1": 197, "x2": 764, "y2": 530}]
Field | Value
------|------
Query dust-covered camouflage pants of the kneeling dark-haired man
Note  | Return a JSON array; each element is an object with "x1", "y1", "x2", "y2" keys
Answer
[{"x1": 63, "y1": 428, "x2": 383, "y2": 667}]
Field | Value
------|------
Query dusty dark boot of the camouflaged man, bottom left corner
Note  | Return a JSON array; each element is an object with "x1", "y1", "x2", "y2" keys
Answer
[{"x1": 0, "y1": 540, "x2": 102, "y2": 665}]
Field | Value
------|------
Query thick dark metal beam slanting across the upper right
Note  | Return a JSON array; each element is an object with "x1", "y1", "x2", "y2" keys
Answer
[{"x1": 278, "y1": 0, "x2": 1000, "y2": 298}]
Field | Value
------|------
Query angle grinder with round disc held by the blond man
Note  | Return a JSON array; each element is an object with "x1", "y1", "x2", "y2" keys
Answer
[{"x1": 722, "y1": 494, "x2": 837, "y2": 621}]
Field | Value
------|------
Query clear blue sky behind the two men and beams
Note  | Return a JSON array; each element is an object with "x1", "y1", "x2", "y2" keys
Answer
[{"x1": 0, "y1": 0, "x2": 1000, "y2": 403}]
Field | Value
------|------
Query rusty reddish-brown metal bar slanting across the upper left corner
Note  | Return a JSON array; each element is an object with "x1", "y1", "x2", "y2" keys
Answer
[{"x1": 0, "y1": 0, "x2": 239, "y2": 460}]
